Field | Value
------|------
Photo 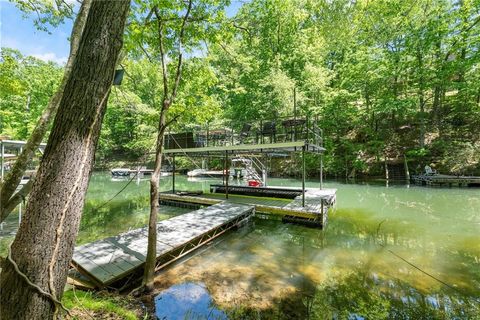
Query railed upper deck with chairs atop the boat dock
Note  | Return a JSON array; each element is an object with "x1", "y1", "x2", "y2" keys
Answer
[{"x1": 163, "y1": 115, "x2": 325, "y2": 156}]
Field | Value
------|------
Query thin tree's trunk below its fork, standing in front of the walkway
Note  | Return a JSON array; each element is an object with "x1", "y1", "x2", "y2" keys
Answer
[{"x1": 143, "y1": 108, "x2": 168, "y2": 291}]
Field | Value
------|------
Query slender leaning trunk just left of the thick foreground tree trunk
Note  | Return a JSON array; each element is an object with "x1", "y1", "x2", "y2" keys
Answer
[{"x1": 0, "y1": 0, "x2": 92, "y2": 222}]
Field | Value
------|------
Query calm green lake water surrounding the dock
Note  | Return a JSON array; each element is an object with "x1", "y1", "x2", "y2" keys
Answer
[{"x1": 0, "y1": 173, "x2": 480, "y2": 319}]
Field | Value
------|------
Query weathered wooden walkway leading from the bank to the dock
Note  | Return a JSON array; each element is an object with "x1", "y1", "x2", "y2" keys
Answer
[{"x1": 72, "y1": 202, "x2": 254, "y2": 288}]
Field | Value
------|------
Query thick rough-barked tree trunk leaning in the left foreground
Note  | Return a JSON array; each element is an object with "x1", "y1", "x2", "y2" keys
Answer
[{"x1": 0, "y1": 0, "x2": 130, "y2": 320}]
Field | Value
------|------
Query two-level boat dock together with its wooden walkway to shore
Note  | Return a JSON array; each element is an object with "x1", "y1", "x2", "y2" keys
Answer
[{"x1": 70, "y1": 117, "x2": 336, "y2": 288}]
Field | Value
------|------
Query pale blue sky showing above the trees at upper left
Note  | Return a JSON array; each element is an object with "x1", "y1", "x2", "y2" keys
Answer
[{"x1": 0, "y1": 0, "x2": 245, "y2": 64}]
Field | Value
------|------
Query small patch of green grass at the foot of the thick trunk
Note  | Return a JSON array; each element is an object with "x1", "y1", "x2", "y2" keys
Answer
[{"x1": 62, "y1": 290, "x2": 138, "y2": 320}]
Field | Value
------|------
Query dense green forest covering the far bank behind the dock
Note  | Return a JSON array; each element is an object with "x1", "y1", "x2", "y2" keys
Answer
[{"x1": 0, "y1": 0, "x2": 480, "y2": 177}]
